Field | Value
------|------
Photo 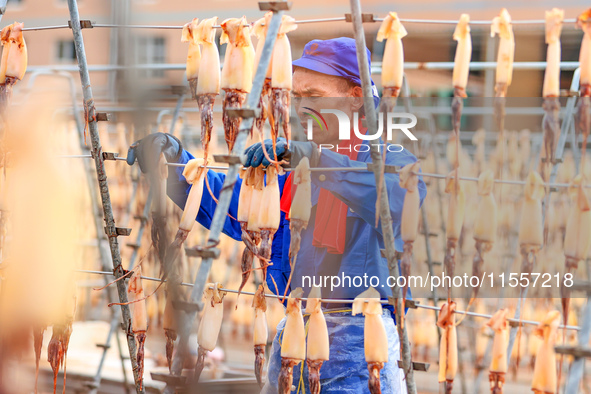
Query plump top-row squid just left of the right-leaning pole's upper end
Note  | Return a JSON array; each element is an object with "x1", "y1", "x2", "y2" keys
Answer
[{"x1": 220, "y1": 17, "x2": 252, "y2": 152}]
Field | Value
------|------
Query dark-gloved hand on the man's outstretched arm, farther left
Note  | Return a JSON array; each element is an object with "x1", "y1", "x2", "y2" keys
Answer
[{"x1": 127, "y1": 133, "x2": 183, "y2": 173}]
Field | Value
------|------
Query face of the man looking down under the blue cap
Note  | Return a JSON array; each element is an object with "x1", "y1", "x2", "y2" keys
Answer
[{"x1": 292, "y1": 67, "x2": 362, "y2": 145}]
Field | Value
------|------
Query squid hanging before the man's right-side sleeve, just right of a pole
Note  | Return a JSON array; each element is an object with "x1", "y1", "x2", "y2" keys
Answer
[{"x1": 399, "y1": 161, "x2": 421, "y2": 314}]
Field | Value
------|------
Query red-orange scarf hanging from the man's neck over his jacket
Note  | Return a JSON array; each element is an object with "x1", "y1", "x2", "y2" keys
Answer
[{"x1": 280, "y1": 127, "x2": 365, "y2": 254}]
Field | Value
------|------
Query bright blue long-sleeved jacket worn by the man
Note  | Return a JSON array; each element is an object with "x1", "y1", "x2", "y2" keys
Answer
[{"x1": 167, "y1": 141, "x2": 427, "y2": 307}]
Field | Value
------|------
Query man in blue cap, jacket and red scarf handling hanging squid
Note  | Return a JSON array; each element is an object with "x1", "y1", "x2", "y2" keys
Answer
[{"x1": 128, "y1": 37, "x2": 426, "y2": 393}]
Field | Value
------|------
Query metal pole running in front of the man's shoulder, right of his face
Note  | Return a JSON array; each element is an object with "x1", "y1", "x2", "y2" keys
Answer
[{"x1": 350, "y1": 0, "x2": 417, "y2": 394}]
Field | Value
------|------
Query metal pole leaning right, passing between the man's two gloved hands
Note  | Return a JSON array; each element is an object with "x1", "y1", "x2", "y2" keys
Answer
[{"x1": 163, "y1": 7, "x2": 283, "y2": 394}]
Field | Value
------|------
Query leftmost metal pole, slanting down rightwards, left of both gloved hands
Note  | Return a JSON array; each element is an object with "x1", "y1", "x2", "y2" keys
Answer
[{"x1": 68, "y1": 0, "x2": 144, "y2": 393}]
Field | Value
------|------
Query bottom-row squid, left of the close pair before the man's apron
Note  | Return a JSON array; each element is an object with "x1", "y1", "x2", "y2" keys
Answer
[{"x1": 279, "y1": 287, "x2": 306, "y2": 394}]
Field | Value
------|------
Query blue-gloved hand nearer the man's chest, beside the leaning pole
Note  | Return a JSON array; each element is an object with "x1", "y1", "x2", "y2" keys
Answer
[{"x1": 244, "y1": 138, "x2": 320, "y2": 168}]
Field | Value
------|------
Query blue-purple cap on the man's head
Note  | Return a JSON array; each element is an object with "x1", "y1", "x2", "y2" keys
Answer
[{"x1": 292, "y1": 37, "x2": 380, "y2": 108}]
